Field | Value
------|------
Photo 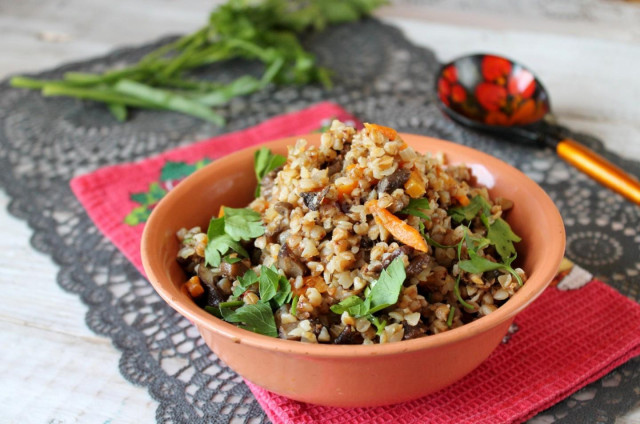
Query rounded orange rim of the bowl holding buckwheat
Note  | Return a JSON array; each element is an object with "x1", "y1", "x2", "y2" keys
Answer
[{"x1": 141, "y1": 133, "x2": 566, "y2": 358}]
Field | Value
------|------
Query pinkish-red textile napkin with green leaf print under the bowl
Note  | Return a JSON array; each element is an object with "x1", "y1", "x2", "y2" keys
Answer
[{"x1": 71, "y1": 103, "x2": 640, "y2": 424}]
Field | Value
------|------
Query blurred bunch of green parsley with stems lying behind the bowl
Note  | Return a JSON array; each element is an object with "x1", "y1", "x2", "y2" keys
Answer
[{"x1": 11, "y1": 0, "x2": 385, "y2": 122}]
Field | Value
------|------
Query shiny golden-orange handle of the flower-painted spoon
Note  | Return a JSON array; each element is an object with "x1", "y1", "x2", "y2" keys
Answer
[{"x1": 556, "y1": 138, "x2": 640, "y2": 205}]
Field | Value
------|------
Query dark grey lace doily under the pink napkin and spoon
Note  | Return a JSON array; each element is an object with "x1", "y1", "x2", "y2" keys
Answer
[{"x1": 0, "y1": 20, "x2": 640, "y2": 423}]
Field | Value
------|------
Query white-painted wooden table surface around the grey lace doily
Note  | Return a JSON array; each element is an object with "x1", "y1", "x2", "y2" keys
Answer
[{"x1": 0, "y1": 0, "x2": 640, "y2": 423}]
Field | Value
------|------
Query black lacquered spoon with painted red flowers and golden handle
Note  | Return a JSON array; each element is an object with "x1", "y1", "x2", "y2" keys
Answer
[{"x1": 436, "y1": 54, "x2": 640, "y2": 205}]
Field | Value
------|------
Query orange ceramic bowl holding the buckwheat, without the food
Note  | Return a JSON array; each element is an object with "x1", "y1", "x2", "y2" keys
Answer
[{"x1": 142, "y1": 134, "x2": 565, "y2": 407}]
